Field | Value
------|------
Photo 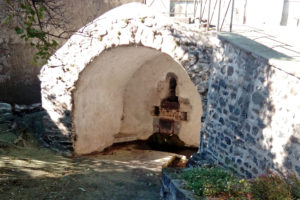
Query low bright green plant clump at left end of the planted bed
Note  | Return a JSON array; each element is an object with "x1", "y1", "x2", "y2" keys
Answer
[{"x1": 181, "y1": 167, "x2": 249, "y2": 199}]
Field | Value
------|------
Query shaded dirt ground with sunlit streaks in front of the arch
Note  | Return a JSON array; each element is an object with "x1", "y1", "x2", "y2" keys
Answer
[{"x1": 0, "y1": 133, "x2": 196, "y2": 200}]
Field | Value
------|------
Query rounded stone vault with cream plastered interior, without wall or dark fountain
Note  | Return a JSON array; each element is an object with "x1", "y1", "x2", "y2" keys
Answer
[{"x1": 40, "y1": 3, "x2": 211, "y2": 154}]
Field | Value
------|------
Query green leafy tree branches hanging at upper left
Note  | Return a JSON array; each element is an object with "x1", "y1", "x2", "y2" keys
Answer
[{"x1": 4, "y1": 0, "x2": 71, "y2": 64}]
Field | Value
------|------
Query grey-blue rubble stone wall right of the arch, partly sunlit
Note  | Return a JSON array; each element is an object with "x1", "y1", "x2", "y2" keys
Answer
[{"x1": 202, "y1": 34, "x2": 300, "y2": 178}]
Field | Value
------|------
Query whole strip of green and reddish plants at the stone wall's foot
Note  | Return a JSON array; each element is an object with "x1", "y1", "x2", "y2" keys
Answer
[{"x1": 181, "y1": 167, "x2": 300, "y2": 200}]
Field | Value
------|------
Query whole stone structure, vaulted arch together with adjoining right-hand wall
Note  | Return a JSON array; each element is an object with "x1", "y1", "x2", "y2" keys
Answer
[{"x1": 40, "y1": 3, "x2": 300, "y2": 177}]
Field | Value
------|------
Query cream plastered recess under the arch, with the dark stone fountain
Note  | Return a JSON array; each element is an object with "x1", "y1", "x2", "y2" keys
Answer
[{"x1": 73, "y1": 46, "x2": 202, "y2": 154}]
